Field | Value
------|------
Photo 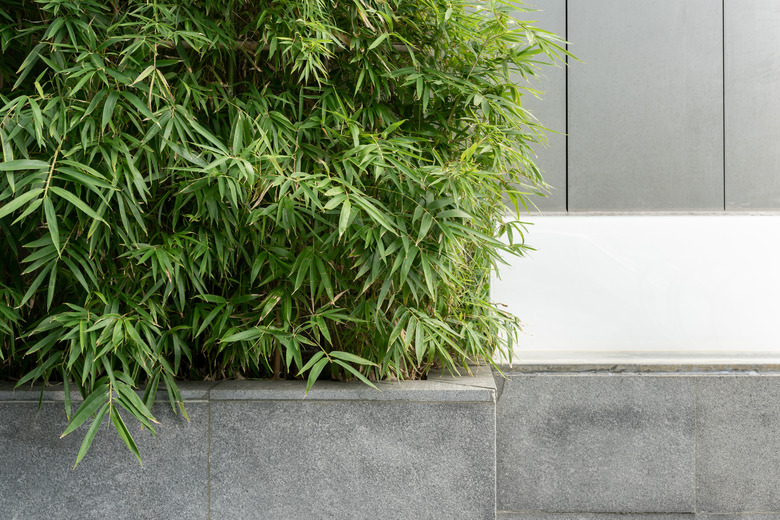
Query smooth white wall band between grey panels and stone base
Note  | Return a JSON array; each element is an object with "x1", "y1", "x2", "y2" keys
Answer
[{"x1": 491, "y1": 214, "x2": 780, "y2": 362}]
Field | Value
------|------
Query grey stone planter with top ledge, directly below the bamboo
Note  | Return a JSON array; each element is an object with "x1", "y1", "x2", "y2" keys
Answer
[{"x1": 0, "y1": 369, "x2": 496, "y2": 520}]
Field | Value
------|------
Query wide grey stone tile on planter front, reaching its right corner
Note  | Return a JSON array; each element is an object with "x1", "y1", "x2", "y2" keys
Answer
[{"x1": 211, "y1": 401, "x2": 495, "y2": 520}]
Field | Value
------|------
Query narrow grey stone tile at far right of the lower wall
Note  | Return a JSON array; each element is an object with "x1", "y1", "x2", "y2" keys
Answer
[{"x1": 696, "y1": 375, "x2": 780, "y2": 513}]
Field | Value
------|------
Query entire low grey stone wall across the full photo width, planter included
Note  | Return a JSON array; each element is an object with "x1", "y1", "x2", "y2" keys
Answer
[{"x1": 6, "y1": 365, "x2": 780, "y2": 520}]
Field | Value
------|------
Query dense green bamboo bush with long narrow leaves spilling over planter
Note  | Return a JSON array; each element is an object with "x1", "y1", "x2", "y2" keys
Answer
[{"x1": 0, "y1": 0, "x2": 565, "y2": 460}]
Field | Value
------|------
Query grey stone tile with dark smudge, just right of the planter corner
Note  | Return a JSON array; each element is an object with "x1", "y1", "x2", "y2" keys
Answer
[{"x1": 496, "y1": 375, "x2": 694, "y2": 513}]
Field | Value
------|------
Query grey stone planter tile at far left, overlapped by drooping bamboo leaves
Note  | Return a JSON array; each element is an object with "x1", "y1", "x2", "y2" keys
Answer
[{"x1": 0, "y1": 402, "x2": 208, "y2": 520}]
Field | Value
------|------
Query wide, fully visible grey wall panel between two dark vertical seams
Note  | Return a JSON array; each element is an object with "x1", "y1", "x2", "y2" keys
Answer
[{"x1": 568, "y1": 0, "x2": 724, "y2": 211}]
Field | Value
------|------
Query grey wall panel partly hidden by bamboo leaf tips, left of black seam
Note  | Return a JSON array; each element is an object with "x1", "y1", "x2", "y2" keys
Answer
[{"x1": 516, "y1": 0, "x2": 566, "y2": 212}]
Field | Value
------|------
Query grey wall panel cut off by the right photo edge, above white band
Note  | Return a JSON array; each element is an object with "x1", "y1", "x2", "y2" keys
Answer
[{"x1": 724, "y1": 0, "x2": 780, "y2": 209}]
